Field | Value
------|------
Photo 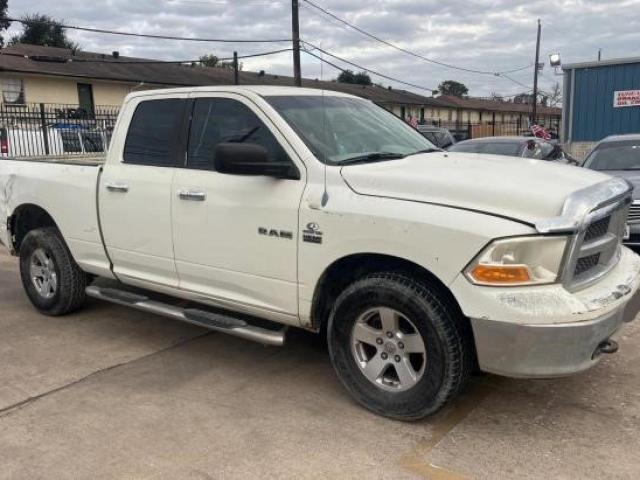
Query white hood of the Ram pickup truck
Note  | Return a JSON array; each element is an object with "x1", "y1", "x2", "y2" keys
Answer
[{"x1": 341, "y1": 152, "x2": 610, "y2": 224}]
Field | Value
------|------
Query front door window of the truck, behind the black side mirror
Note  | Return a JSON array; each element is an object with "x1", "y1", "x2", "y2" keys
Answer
[{"x1": 187, "y1": 98, "x2": 290, "y2": 170}]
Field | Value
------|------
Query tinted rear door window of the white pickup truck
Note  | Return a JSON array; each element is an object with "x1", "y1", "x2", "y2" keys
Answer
[{"x1": 123, "y1": 98, "x2": 184, "y2": 167}]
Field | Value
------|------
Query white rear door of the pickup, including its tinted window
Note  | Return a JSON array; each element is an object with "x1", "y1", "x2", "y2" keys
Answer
[{"x1": 99, "y1": 94, "x2": 187, "y2": 287}]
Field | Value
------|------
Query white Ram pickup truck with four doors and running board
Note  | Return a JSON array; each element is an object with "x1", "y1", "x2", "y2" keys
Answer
[{"x1": 0, "y1": 86, "x2": 640, "y2": 419}]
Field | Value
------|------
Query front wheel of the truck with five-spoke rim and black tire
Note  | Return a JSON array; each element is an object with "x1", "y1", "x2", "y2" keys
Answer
[{"x1": 327, "y1": 272, "x2": 475, "y2": 421}]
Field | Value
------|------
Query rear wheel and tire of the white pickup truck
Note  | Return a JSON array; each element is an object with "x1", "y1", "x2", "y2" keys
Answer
[{"x1": 20, "y1": 227, "x2": 88, "y2": 316}]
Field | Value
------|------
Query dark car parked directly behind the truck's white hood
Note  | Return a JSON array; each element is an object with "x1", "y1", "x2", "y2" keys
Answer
[{"x1": 449, "y1": 136, "x2": 579, "y2": 165}]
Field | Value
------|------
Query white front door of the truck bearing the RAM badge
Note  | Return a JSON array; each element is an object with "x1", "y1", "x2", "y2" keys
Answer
[{"x1": 173, "y1": 93, "x2": 305, "y2": 323}]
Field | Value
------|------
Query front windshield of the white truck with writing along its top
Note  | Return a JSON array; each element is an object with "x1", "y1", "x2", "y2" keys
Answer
[{"x1": 266, "y1": 94, "x2": 437, "y2": 165}]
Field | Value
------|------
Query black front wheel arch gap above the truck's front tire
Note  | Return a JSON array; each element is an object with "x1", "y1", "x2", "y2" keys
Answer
[{"x1": 311, "y1": 253, "x2": 471, "y2": 334}]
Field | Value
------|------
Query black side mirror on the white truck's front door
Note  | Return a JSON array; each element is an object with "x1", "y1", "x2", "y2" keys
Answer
[{"x1": 214, "y1": 142, "x2": 300, "y2": 180}]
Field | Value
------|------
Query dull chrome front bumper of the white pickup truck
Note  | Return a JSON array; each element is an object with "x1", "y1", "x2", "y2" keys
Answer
[{"x1": 471, "y1": 290, "x2": 640, "y2": 378}]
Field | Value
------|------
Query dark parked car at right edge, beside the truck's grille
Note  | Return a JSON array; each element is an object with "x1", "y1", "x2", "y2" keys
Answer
[{"x1": 583, "y1": 134, "x2": 640, "y2": 247}]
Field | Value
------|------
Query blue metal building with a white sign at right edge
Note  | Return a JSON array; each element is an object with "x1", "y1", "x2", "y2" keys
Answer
[{"x1": 562, "y1": 57, "x2": 640, "y2": 146}]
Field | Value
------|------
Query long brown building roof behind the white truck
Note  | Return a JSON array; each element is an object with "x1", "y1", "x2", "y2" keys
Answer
[{"x1": 0, "y1": 44, "x2": 561, "y2": 116}]
